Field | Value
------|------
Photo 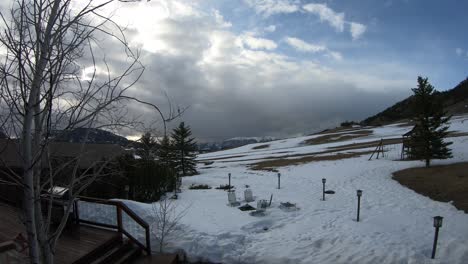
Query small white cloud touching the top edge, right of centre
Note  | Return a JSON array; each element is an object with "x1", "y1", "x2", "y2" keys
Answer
[{"x1": 244, "y1": 0, "x2": 299, "y2": 17}]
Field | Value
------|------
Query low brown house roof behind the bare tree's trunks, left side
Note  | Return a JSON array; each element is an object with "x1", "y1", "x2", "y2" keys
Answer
[{"x1": 0, "y1": 139, "x2": 126, "y2": 168}]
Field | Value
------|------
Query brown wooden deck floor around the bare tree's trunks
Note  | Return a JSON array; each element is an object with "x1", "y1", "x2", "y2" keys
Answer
[{"x1": 0, "y1": 203, "x2": 120, "y2": 264}]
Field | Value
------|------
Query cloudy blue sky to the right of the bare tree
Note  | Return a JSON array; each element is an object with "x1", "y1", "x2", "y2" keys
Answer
[{"x1": 3, "y1": 0, "x2": 468, "y2": 140}]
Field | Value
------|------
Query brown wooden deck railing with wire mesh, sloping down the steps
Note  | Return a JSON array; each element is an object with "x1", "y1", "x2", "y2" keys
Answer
[{"x1": 74, "y1": 197, "x2": 151, "y2": 255}]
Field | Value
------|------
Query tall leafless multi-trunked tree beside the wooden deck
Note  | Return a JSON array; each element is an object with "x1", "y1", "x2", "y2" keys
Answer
[{"x1": 0, "y1": 0, "x2": 178, "y2": 263}]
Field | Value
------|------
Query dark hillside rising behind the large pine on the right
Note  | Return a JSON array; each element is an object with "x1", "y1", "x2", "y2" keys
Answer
[{"x1": 361, "y1": 78, "x2": 468, "y2": 125}]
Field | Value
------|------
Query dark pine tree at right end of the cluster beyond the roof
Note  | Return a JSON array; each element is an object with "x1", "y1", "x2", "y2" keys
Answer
[{"x1": 171, "y1": 122, "x2": 198, "y2": 176}]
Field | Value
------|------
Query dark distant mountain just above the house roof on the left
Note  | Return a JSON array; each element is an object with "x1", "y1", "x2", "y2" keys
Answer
[{"x1": 51, "y1": 128, "x2": 132, "y2": 146}]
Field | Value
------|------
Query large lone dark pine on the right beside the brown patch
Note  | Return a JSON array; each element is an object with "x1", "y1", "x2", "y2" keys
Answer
[{"x1": 407, "y1": 77, "x2": 452, "y2": 167}]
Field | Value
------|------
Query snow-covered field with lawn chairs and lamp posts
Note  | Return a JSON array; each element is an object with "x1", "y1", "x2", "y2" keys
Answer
[{"x1": 129, "y1": 116, "x2": 468, "y2": 263}]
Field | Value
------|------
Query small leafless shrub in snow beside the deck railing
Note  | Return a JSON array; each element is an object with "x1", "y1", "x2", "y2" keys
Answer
[{"x1": 150, "y1": 197, "x2": 188, "y2": 253}]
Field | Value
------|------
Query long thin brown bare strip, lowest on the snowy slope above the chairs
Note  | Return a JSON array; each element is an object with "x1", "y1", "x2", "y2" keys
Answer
[{"x1": 250, "y1": 151, "x2": 372, "y2": 171}]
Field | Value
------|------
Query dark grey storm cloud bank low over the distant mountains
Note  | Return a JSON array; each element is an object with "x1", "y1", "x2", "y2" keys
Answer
[{"x1": 128, "y1": 48, "x2": 407, "y2": 140}]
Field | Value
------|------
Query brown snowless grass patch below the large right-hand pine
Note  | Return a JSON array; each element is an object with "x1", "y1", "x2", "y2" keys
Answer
[{"x1": 393, "y1": 162, "x2": 468, "y2": 213}]
